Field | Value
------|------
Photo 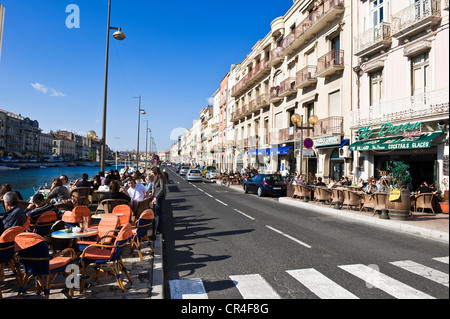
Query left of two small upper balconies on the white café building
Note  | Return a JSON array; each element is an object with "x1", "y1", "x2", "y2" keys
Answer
[{"x1": 355, "y1": 22, "x2": 392, "y2": 57}]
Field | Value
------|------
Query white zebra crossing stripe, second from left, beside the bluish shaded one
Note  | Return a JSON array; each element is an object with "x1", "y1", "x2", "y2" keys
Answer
[{"x1": 230, "y1": 274, "x2": 281, "y2": 299}]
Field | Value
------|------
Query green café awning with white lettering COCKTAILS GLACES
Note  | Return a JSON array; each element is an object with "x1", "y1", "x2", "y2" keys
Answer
[{"x1": 350, "y1": 132, "x2": 442, "y2": 151}]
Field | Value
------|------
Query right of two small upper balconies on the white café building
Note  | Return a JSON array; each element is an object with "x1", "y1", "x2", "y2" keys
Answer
[{"x1": 391, "y1": 0, "x2": 441, "y2": 39}]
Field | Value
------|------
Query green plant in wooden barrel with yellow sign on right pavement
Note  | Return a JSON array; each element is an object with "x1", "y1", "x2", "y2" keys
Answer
[{"x1": 386, "y1": 161, "x2": 412, "y2": 220}]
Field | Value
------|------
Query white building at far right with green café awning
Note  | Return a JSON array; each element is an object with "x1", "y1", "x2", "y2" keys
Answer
[{"x1": 351, "y1": 0, "x2": 449, "y2": 189}]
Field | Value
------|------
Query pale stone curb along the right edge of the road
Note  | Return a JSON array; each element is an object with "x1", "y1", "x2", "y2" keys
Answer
[{"x1": 278, "y1": 197, "x2": 449, "y2": 244}]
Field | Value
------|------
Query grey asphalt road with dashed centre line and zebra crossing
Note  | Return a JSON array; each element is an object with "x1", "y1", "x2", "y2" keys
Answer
[{"x1": 164, "y1": 168, "x2": 449, "y2": 299}]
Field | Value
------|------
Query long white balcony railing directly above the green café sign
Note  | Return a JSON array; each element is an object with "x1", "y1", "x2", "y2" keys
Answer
[{"x1": 351, "y1": 87, "x2": 449, "y2": 128}]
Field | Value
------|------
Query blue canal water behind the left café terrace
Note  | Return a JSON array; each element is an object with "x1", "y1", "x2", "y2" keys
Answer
[{"x1": 0, "y1": 165, "x2": 123, "y2": 202}]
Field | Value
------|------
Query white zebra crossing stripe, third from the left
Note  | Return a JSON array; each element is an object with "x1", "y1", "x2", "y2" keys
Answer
[{"x1": 286, "y1": 268, "x2": 359, "y2": 299}]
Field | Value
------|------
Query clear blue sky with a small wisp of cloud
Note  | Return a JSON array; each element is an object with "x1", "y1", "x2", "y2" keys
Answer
[{"x1": 0, "y1": 0, "x2": 293, "y2": 151}]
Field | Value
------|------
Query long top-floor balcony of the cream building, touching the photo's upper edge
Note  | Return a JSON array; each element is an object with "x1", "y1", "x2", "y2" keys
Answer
[{"x1": 282, "y1": 0, "x2": 345, "y2": 56}]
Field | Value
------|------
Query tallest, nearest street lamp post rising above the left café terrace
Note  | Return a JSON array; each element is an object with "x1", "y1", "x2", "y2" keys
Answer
[{"x1": 100, "y1": 0, "x2": 126, "y2": 172}]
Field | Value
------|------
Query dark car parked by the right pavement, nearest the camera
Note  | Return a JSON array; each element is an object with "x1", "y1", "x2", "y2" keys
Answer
[{"x1": 243, "y1": 174, "x2": 287, "y2": 197}]
